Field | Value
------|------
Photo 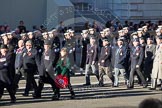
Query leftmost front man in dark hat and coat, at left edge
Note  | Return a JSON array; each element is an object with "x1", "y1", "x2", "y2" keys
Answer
[{"x1": 0, "y1": 45, "x2": 16, "y2": 103}]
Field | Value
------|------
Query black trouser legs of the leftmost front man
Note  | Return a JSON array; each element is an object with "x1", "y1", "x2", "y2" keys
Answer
[{"x1": 0, "y1": 81, "x2": 16, "y2": 100}]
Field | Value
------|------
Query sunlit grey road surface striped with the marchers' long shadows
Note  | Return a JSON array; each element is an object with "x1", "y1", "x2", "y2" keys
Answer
[{"x1": 0, "y1": 75, "x2": 162, "y2": 108}]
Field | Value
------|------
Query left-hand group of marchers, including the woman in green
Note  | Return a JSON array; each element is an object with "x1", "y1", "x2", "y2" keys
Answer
[{"x1": 0, "y1": 29, "x2": 75, "y2": 103}]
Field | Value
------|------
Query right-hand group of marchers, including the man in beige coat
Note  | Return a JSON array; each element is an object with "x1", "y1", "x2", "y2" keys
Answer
[{"x1": 80, "y1": 26, "x2": 162, "y2": 90}]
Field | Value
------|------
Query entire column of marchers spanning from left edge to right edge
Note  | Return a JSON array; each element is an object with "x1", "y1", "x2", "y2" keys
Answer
[{"x1": 0, "y1": 26, "x2": 162, "y2": 102}]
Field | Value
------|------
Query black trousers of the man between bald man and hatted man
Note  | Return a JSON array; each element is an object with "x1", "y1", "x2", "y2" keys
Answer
[{"x1": 24, "y1": 69, "x2": 37, "y2": 94}]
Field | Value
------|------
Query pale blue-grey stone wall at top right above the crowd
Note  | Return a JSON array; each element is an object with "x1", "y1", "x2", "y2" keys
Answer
[{"x1": 95, "y1": 0, "x2": 162, "y2": 20}]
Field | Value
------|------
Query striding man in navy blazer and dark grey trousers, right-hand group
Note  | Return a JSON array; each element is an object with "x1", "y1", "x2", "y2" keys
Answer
[{"x1": 128, "y1": 38, "x2": 147, "y2": 88}]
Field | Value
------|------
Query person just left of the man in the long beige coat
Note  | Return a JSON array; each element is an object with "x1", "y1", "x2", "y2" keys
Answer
[{"x1": 144, "y1": 37, "x2": 156, "y2": 82}]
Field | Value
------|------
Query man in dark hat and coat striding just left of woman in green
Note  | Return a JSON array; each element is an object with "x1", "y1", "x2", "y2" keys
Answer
[{"x1": 33, "y1": 40, "x2": 58, "y2": 100}]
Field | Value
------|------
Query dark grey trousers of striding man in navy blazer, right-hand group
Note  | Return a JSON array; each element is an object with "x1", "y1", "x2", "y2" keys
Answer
[{"x1": 129, "y1": 67, "x2": 147, "y2": 87}]
